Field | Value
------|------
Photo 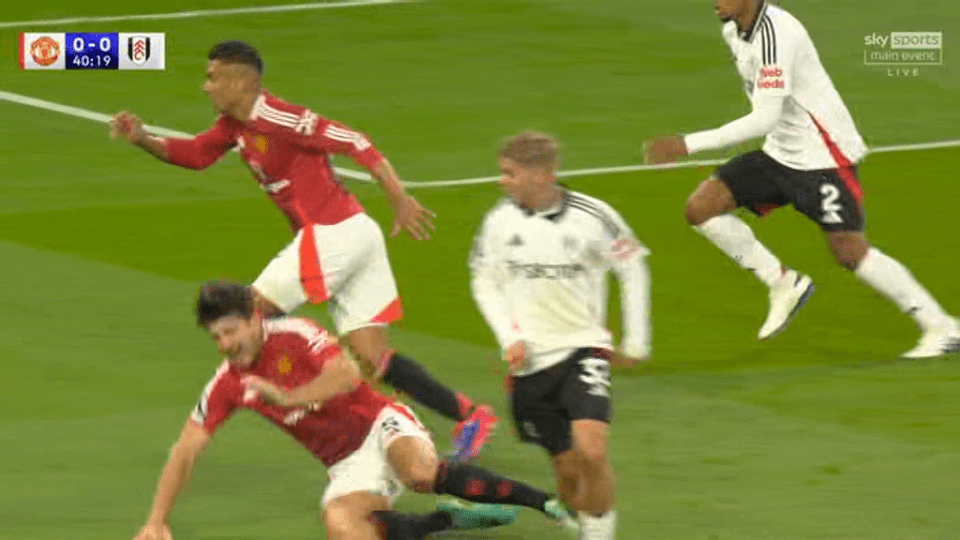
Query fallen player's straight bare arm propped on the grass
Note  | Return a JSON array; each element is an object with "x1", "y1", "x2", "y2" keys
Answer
[{"x1": 134, "y1": 419, "x2": 210, "y2": 540}]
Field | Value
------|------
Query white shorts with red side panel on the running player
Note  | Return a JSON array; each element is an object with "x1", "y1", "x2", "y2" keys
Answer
[{"x1": 253, "y1": 213, "x2": 403, "y2": 334}]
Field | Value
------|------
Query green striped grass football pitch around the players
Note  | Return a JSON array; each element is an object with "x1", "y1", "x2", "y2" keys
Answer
[{"x1": 0, "y1": 0, "x2": 960, "y2": 540}]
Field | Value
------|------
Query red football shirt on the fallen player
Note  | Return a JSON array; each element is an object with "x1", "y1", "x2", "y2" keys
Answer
[{"x1": 190, "y1": 317, "x2": 392, "y2": 467}]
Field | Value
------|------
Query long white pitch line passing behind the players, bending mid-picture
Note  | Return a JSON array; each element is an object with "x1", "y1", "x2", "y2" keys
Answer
[{"x1": 0, "y1": 90, "x2": 960, "y2": 189}]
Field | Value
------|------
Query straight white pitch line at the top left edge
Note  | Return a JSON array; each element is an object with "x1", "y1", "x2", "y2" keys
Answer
[{"x1": 0, "y1": 0, "x2": 415, "y2": 28}]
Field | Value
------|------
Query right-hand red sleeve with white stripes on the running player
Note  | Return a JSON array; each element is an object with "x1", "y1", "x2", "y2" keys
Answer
[{"x1": 290, "y1": 110, "x2": 383, "y2": 170}]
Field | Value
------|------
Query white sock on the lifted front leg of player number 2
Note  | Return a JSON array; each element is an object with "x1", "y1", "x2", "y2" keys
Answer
[{"x1": 693, "y1": 214, "x2": 783, "y2": 287}]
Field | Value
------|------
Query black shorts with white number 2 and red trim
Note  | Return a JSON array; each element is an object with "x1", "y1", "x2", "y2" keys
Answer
[{"x1": 715, "y1": 150, "x2": 864, "y2": 232}]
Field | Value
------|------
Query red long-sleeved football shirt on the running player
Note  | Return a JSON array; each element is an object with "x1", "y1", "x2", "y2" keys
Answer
[{"x1": 164, "y1": 92, "x2": 383, "y2": 230}]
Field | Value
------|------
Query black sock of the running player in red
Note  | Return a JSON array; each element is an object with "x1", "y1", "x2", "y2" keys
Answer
[{"x1": 383, "y1": 353, "x2": 472, "y2": 422}]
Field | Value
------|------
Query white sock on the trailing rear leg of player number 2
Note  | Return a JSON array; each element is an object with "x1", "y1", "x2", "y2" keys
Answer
[{"x1": 856, "y1": 247, "x2": 950, "y2": 332}]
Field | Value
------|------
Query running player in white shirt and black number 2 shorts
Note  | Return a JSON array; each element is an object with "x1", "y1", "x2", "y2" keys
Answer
[{"x1": 645, "y1": 0, "x2": 960, "y2": 358}]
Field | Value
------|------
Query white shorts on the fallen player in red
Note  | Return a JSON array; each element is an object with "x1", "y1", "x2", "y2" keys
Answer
[{"x1": 321, "y1": 403, "x2": 433, "y2": 508}]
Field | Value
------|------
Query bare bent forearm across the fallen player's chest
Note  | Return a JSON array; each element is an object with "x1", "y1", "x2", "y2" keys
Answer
[{"x1": 241, "y1": 352, "x2": 363, "y2": 407}]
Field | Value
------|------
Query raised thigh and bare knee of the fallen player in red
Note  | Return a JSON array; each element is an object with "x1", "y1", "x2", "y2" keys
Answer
[{"x1": 374, "y1": 403, "x2": 439, "y2": 493}]
